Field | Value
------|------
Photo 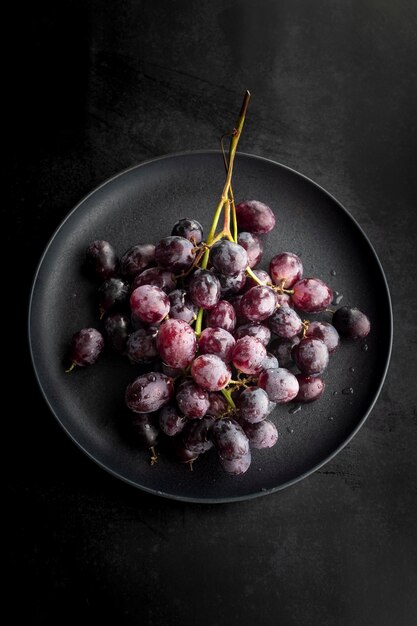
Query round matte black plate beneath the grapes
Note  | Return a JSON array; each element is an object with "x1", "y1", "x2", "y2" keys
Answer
[{"x1": 29, "y1": 152, "x2": 392, "y2": 502}]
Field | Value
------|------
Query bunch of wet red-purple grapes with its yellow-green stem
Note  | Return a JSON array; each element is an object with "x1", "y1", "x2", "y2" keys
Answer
[{"x1": 69, "y1": 94, "x2": 370, "y2": 475}]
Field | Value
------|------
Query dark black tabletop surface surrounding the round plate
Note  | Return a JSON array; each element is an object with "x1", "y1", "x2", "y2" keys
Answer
[{"x1": 7, "y1": 0, "x2": 417, "y2": 626}]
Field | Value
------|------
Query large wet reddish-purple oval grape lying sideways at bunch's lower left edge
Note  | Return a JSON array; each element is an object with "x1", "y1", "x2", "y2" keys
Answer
[{"x1": 125, "y1": 372, "x2": 174, "y2": 413}]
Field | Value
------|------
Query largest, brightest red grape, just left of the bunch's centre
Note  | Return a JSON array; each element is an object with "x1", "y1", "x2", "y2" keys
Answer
[{"x1": 156, "y1": 319, "x2": 197, "y2": 369}]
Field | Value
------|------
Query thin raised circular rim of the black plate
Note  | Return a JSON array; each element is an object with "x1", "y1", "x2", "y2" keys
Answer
[{"x1": 27, "y1": 149, "x2": 394, "y2": 504}]
